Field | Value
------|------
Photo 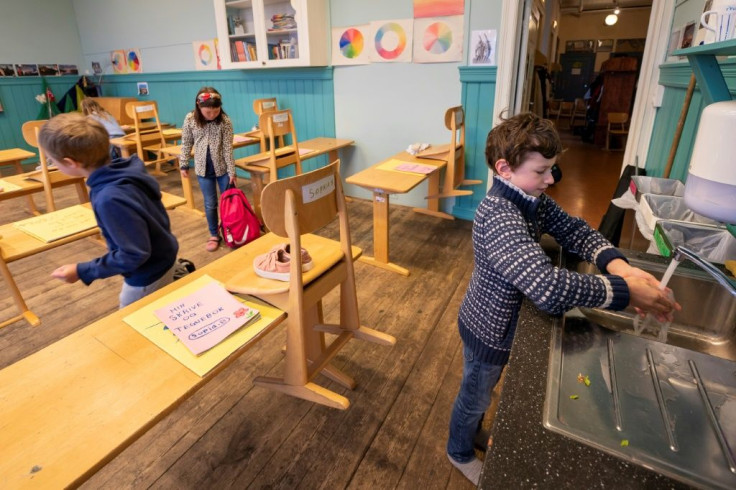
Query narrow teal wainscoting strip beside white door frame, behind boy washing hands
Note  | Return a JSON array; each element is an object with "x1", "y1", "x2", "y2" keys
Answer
[{"x1": 452, "y1": 66, "x2": 496, "y2": 220}]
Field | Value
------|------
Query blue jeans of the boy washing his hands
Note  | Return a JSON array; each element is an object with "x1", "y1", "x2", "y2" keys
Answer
[{"x1": 447, "y1": 346, "x2": 503, "y2": 463}]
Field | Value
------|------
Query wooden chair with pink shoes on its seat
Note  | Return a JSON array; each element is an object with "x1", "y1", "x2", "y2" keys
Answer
[{"x1": 226, "y1": 160, "x2": 396, "y2": 409}]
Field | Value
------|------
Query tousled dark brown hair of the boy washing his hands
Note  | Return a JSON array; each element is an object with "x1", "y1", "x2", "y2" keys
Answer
[{"x1": 486, "y1": 112, "x2": 562, "y2": 172}]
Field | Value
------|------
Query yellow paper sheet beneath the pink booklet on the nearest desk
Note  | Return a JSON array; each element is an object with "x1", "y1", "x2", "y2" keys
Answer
[{"x1": 123, "y1": 274, "x2": 283, "y2": 376}]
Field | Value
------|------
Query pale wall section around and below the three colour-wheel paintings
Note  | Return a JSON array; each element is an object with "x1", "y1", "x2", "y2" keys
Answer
[{"x1": 330, "y1": 0, "x2": 501, "y2": 209}]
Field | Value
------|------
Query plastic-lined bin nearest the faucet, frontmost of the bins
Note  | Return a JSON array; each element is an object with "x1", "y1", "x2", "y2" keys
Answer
[{"x1": 653, "y1": 220, "x2": 736, "y2": 264}]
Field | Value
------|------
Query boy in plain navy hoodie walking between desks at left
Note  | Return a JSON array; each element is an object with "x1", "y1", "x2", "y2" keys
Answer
[{"x1": 38, "y1": 112, "x2": 179, "y2": 308}]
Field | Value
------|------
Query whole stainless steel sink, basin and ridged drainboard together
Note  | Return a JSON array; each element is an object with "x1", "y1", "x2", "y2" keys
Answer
[{"x1": 544, "y1": 251, "x2": 736, "y2": 489}]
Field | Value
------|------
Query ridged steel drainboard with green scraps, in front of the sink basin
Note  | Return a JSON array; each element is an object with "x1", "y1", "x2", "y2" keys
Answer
[{"x1": 544, "y1": 310, "x2": 736, "y2": 489}]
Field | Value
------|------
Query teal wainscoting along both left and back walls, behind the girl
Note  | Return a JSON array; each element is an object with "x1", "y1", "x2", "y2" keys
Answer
[{"x1": 0, "y1": 67, "x2": 335, "y2": 175}]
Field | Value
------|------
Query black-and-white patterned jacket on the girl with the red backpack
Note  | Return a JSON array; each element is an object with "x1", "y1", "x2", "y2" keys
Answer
[{"x1": 179, "y1": 112, "x2": 235, "y2": 177}]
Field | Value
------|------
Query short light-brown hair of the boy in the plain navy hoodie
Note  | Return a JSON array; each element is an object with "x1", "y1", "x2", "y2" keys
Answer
[{"x1": 38, "y1": 112, "x2": 110, "y2": 168}]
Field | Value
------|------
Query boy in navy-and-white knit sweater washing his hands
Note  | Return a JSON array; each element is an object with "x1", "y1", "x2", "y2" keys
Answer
[{"x1": 447, "y1": 113, "x2": 680, "y2": 485}]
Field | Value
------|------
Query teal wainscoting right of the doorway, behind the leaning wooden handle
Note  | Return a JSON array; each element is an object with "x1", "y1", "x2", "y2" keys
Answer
[{"x1": 646, "y1": 60, "x2": 736, "y2": 182}]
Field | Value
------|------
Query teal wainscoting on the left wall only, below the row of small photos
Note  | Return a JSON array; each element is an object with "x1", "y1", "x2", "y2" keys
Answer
[{"x1": 0, "y1": 75, "x2": 86, "y2": 163}]
